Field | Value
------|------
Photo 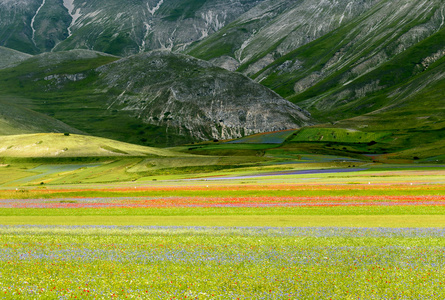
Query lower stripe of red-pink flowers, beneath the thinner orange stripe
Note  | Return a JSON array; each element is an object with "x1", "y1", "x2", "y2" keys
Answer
[{"x1": 0, "y1": 195, "x2": 445, "y2": 208}]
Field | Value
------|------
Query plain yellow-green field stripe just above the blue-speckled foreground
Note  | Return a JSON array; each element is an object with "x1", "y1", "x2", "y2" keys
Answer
[{"x1": 0, "y1": 215, "x2": 445, "y2": 228}]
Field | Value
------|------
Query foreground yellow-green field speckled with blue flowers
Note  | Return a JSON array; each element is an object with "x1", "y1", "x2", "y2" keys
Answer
[{"x1": 0, "y1": 226, "x2": 445, "y2": 299}]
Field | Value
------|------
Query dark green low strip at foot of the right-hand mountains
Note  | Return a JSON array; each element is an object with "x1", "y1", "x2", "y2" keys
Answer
[{"x1": 178, "y1": 126, "x2": 445, "y2": 163}]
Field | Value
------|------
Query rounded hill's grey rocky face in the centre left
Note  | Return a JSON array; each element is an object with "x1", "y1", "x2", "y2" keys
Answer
[{"x1": 97, "y1": 51, "x2": 311, "y2": 140}]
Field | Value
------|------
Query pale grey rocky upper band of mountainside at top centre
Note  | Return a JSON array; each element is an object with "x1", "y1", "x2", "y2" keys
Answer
[{"x1": 186, "y1": 0, "x2": 378, "y2": 75}]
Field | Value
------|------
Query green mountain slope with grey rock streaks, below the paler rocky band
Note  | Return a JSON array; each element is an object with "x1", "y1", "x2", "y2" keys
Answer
[{"x1": 246, "y1": 0, "x2": 445, "y2": 120}]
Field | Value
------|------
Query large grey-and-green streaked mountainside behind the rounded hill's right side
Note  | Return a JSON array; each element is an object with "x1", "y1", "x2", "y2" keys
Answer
[{"x1": 187, "y1": 0, "x2": 445, "y2": 115}]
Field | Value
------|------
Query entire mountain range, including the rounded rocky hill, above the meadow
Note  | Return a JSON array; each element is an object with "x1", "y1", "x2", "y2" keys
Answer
[{"x1": 0, "y1": 0, "x2": 445, "y2": 153}]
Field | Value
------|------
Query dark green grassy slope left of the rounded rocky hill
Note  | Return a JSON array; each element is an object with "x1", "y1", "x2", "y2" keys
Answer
[{"x1": 0, "y1": 50, "x2": 191, "y2": 146}]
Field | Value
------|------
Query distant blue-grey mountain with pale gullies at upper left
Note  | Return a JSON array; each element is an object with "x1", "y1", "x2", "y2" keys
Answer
[{"x1": 0, "y1": 0, "x2": 261, "y2": 55}]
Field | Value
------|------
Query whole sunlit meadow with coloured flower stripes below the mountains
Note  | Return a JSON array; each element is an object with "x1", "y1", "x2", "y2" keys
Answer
[{"x1": 0, "y1": 142, "x2": 445, "y2": 299}]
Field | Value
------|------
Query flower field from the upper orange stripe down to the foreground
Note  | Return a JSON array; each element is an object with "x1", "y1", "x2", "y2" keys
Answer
[{"x1": 0, "y1": 175, "x2": 445, "y2": 299}]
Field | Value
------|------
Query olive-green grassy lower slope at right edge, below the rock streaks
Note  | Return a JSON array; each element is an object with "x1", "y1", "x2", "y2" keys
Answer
[{"x1": 286, "y1": 25, "x2": 445, "y2": 161}]
